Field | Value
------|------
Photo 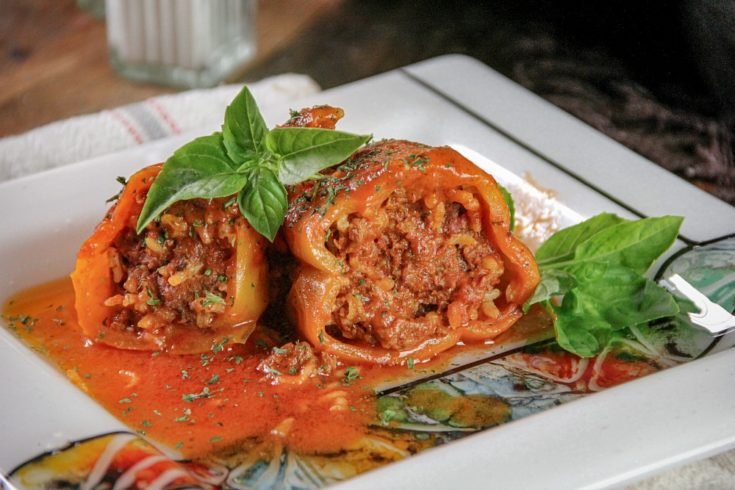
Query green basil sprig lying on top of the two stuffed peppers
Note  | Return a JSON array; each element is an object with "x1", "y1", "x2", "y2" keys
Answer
[{"x1": 136, "y1": 87, "x2": 371, "y2": 241}]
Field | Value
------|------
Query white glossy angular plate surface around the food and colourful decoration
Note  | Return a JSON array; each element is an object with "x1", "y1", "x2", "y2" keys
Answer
[{"x1": 0, "y1": 56, "x2": 735, "y2": 489}]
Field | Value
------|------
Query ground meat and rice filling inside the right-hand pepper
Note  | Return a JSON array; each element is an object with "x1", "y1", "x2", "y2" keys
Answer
[{"x1": 327, "y1": 188, "x2": 503, "y2": 350}]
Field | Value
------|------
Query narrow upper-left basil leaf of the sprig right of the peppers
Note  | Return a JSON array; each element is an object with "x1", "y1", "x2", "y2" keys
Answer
[{"x1": 536, "y1": 213, "x2": 625, "y2": 266}]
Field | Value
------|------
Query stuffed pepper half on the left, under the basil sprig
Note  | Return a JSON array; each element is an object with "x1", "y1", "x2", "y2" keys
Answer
[{"x1": 72, "y1": 165, "x2": 268, "y2": 353}]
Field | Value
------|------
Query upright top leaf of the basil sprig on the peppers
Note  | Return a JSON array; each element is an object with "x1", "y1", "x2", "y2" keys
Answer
[{"x1": 222, "y1": 87, "x2": 268, "y2": 164}]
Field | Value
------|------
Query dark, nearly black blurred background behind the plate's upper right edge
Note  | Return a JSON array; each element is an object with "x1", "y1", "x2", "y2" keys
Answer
[{"x1": 246, "y1": 0, "x2": 735, "y2": 203}]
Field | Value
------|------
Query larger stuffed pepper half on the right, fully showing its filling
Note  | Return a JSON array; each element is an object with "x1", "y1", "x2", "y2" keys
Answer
[{"x1": 284, "y1": 141, "x2": 539, "y2": 365}]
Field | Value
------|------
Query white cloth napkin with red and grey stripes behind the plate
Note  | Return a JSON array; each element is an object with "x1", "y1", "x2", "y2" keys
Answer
[{"x1": 0, "y1": 74, "x2": 320, "y2": 181}]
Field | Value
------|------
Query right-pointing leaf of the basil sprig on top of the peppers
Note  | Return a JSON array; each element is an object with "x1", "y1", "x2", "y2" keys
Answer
[{"x1": 265, "y1": 128, "x2": 372, "y2": 185}]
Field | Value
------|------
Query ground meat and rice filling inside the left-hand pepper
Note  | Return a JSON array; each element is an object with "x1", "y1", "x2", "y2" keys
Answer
[{"x1": 105, "y1": 199, "x2": 243, "y2": 331}]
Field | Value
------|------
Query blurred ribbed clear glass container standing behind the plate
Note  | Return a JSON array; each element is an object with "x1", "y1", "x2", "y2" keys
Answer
[{"x1": 106, "y1": 0, "x2": 256, "y2": 88}]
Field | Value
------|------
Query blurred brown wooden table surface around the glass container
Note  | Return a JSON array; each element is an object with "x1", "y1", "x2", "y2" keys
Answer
[{"x1": 0, "y1": 0, "x2": 338, "y2": 136}]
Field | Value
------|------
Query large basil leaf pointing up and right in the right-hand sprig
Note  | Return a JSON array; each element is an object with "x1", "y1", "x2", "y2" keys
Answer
[{"x1": 572, "y1": 216, "x2": 683, "y2": 274}]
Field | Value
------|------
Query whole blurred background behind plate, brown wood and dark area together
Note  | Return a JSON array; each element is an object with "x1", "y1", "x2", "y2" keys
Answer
[{"x1": 0, "y1": 0, "x2": 735, "y2": 204}]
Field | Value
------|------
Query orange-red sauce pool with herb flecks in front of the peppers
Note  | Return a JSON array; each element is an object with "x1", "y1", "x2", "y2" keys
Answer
[{"x1": 3, "y1": 278, "x2": 549, "y2": 459}]
